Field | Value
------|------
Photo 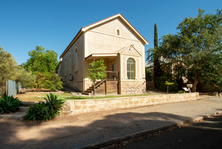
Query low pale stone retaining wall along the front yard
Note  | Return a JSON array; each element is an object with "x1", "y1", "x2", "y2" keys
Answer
[{"x1": 62, "y1": 92, "x2": 199, "y2": 114}]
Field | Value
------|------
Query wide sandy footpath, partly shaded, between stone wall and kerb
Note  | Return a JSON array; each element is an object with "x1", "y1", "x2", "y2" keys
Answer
[{"x1": 0, "y1": 97, "x2": 222, "y2": 149}]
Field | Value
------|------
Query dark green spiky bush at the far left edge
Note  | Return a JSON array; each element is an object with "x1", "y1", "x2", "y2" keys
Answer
[{"x1": 0, "y1": 96, "x2": 21, "y2": 114}]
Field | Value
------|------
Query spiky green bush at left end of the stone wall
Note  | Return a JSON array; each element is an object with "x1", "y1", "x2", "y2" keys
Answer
[{"x1": 26, "y1": 93, "x2": 65, "y2": 121}]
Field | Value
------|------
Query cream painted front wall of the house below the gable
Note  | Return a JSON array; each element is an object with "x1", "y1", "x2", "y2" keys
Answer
[{"x1": 85, "y1": 19, "x2": 145, "y2": 84}]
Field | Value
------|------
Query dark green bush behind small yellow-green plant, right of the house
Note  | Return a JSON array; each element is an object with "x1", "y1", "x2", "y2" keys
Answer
[{"x1": 158, "y1": 73, "x2": 178, "y2": 93}]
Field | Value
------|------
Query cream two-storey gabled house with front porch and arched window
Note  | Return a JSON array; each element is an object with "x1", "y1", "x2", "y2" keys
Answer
[{"x1": 58, "y1": 14, "x2": 148, "y2": 94}]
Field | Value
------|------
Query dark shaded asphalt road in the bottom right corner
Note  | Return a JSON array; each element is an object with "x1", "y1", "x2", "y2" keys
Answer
[{"x1": 118, "y1": 116, "x2": 222, "y2": 149}]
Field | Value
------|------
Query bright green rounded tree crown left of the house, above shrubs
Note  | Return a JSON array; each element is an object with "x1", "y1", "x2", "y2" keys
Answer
[{"x1": 22, "y1": 45, "x2": 58, "y2": 74}]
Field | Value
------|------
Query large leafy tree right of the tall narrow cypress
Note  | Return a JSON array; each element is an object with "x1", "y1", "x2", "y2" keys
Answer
[{"x1": 160, "y1": 9, "x2": 222, "y2": 91}]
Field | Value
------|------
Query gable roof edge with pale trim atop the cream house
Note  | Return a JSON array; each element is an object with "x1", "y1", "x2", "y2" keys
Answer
[{"x1": 60, "y1": 13, "x2": 149, "y2": 58}]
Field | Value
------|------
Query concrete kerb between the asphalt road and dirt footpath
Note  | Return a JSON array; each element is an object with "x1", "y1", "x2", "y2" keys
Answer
[{"x1": 78, "y1": 111, "x2": 222, "y2": 149}]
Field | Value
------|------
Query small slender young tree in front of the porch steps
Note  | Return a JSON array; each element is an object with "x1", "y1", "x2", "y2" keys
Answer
[{"x1": 88, "y1": 59, "x2": 106, "y2": 94}]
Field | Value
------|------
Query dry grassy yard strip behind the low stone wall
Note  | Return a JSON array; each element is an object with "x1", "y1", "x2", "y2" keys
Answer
[{"x1": 16, "y1": 92, "x2": 158, "y2": 101}]
